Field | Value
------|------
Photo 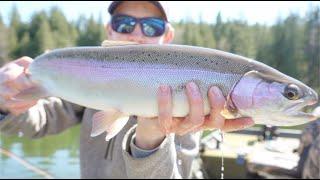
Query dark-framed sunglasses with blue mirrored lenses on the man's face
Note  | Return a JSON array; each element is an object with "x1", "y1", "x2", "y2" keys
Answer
[{"x1": 111, "y1": 14, "x2": 166, "y2": 37}]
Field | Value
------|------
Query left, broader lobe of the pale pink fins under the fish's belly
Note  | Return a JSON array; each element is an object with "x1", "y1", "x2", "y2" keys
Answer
[{"x1": 91, "y1": 109, "x2": 121, "y2": 137}]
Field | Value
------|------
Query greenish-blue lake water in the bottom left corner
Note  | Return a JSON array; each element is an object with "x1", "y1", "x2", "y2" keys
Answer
[{"x1": 0, "y1": 125, "x2": 80, "y2": 179}]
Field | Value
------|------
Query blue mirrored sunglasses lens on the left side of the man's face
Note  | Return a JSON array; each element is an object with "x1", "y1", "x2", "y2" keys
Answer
[{"x1": 111, "y1": 16, "x2": 136, "y2": 33}]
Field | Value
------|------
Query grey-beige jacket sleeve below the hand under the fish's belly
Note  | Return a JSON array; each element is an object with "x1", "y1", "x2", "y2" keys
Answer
[{"x1": 122, "y1": 125, "x2": 200, "y2": 179}]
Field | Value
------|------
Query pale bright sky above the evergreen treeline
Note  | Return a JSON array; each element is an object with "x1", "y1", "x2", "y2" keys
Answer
[{"x1": 0, "y1": 1, "x2": 320, "y2": 25}]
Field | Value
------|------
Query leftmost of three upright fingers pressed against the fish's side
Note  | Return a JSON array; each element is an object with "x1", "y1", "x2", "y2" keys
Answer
[{"x1": 158, "y1": 85, "x2": 172, "y2": 134}]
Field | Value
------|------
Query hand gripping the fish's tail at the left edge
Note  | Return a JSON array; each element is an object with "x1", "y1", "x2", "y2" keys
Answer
[{"x1": 0, "y1": 56, "x2": 37, "y2": 115}]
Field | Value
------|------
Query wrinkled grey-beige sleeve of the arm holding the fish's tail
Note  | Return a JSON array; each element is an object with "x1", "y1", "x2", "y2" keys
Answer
[{"x1": 0, "y1": 97, "x2": 84, "y2": 138}]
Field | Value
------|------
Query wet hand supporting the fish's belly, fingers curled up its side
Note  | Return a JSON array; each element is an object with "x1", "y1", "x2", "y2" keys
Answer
[{"x1": 136, "y1": 82, "x2": 254, "y2": 149}]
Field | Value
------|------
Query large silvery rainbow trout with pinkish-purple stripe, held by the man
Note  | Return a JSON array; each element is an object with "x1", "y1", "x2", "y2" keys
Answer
[{"x1": 18, "y1": 41, "x2": 318, "y2": 140}]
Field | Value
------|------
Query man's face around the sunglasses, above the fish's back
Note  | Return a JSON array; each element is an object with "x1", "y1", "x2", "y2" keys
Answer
[{"x1": 106, "y1": 1, "x2": 174, "y2": 44}]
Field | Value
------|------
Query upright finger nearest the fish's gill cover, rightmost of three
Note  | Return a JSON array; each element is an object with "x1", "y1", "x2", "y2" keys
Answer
[{"x1": 205, "y1": 86, "x2": 226, "y2": 129}]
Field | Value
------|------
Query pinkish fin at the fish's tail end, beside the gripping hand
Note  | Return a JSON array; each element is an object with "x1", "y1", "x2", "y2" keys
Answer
[{"x1": 14, "y1": 86, "x2": 50, "y2": 100}]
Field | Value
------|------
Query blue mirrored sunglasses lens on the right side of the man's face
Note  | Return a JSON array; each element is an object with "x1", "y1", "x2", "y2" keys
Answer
[{"x1": 141, "y1": 18, "x2": 165, "y2": 37}]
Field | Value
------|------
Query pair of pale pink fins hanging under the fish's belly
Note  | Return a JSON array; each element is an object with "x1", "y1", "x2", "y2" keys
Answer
[{"x1": 91, "y1": 109, "x2": 129, "y2": 141}]
